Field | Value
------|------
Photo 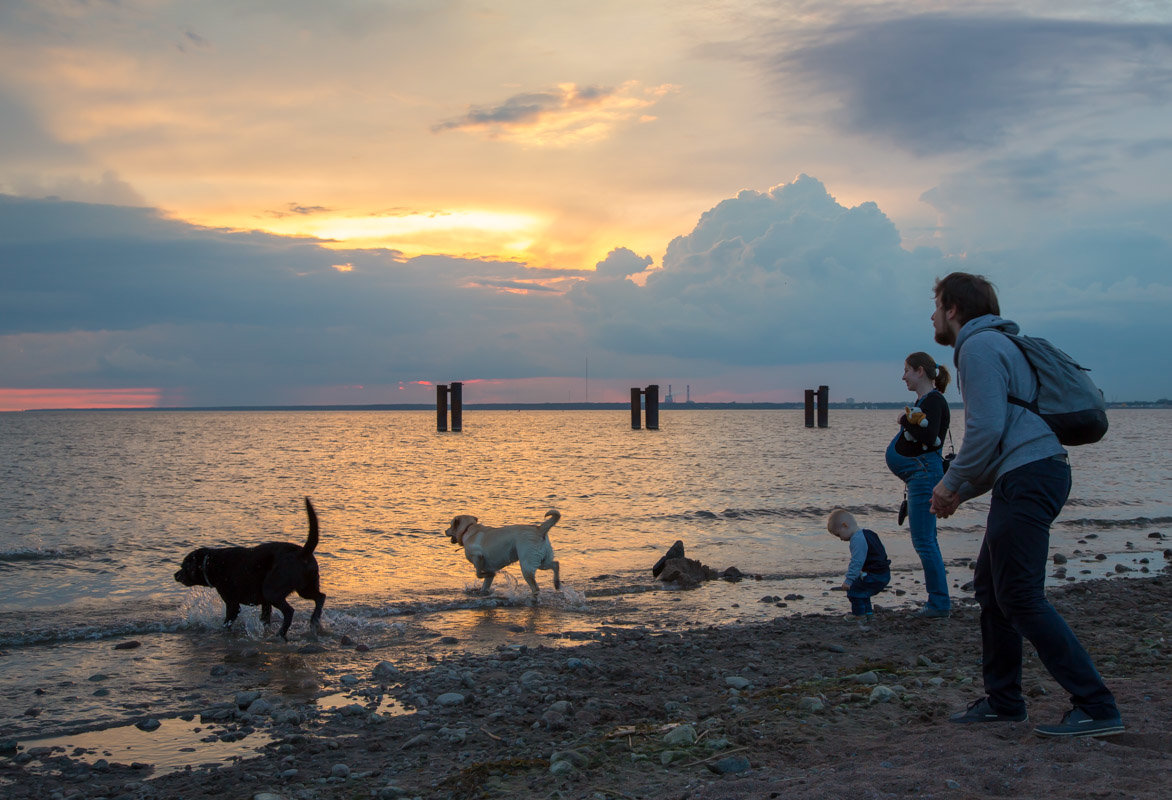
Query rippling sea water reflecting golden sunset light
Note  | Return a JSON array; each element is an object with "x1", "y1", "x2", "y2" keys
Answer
[{"x1": 0, "y1": 409, "x2": 1172, "y2": 739}]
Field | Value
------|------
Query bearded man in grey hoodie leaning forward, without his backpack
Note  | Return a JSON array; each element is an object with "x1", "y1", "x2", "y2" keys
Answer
[{"x1": 932, "y1": 272, "x2": 1124, "y2": 737}]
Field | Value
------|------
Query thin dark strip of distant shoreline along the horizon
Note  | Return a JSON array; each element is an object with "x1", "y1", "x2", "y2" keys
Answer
[{"x1": 0, "y1": 401, "x2": 1172, "y2": 413}]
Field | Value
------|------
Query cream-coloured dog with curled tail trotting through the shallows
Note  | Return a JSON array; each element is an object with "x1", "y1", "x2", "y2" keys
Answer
[{"x1": 444, "y1": 508, "x2": 561, "y2": 600}]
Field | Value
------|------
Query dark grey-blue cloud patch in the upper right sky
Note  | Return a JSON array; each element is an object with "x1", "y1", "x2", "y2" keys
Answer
[{"x1": 774, "y1": 14, "x2": 1172, "y2": 155}]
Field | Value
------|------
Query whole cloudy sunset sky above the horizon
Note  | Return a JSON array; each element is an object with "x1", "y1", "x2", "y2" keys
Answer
[{"x1": 0, "y1": 0, "x2": 1172, "y2": 410}]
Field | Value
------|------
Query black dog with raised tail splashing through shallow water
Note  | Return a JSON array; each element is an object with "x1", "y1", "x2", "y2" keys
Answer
[{"x1": 175, "y1": 498, "x2": 326, "y2": 638}]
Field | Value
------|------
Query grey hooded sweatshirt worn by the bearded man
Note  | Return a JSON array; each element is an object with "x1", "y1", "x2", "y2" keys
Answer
[{"x1": 943, "y1": 314, "x2": 1067, "y2": 500}]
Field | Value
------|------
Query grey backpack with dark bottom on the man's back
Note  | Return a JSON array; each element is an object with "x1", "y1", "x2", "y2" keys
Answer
[{"x1": 999, "y1": 330, "x2": 1106, "y2": 446}]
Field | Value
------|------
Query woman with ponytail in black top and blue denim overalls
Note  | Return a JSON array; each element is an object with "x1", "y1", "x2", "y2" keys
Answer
[{"x1": 886, "y1": 353, "x2": 952, "y2": 618}]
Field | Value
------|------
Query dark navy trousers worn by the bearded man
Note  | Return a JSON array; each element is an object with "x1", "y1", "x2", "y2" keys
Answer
[{"x1": 973, "y1": 458, "x2": 1119, "y2": 719}]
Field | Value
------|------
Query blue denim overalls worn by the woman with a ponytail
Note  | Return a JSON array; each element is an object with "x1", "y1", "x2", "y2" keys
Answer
[{"x1": 886, "y1": 433, "x2": 952, "y2": 611}]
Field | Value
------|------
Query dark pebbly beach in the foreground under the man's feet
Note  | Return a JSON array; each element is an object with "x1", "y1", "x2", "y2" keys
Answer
[{"x1": 0, "y1": 569, "x2": 1172, "y2": 800}]
